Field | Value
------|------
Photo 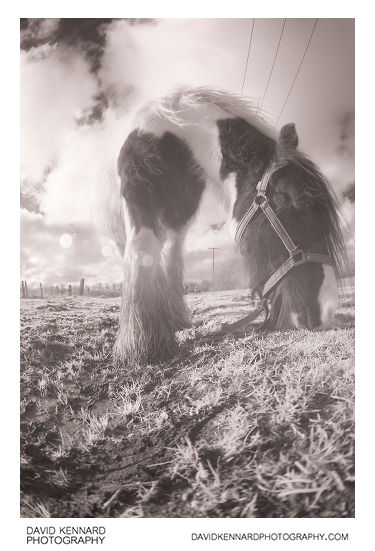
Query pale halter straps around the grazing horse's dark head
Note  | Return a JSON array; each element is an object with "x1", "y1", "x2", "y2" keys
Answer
[{"x1": 234, "y1": 163, "x2": 332, "y2": 298}]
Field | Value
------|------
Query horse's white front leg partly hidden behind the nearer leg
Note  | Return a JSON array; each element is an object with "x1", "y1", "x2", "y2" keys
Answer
[{"x1": 163, "y1": 228, "x2": 191, "y2": 331}]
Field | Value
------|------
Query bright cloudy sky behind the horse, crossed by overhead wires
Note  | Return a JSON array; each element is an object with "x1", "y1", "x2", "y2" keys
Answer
[{"x1": 20, "y1": 18, "x2": 354, "y2": 286}]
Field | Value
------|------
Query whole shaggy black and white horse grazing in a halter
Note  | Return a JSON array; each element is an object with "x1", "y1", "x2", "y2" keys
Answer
[{"x1": 95, "y1": 88, "x2": 343, "y2": 361}]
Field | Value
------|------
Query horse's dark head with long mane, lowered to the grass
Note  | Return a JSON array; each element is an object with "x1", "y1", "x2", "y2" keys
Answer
[{"x1": 241, "y1": 124, "x2": 343, "y2": 329}]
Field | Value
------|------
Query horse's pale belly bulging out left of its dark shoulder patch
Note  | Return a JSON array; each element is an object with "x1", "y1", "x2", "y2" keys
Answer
[{"x1": 91, "y1": 149, "x2": 126, "y2": 257}]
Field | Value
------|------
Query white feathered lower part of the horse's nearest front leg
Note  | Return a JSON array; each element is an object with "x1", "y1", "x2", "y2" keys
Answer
[{"x1": 115, "y1": 222, "x2": 176, "y2": 362}]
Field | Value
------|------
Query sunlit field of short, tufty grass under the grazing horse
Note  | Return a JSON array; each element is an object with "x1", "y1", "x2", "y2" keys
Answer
[{"x1": 21, "y1": 291, "x2": 354, "y2": 517}]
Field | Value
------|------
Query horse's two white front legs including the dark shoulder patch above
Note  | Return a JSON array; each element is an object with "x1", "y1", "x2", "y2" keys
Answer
[{"x1": 115, "y1": 130, "x2": 204, "y2": 362}]
